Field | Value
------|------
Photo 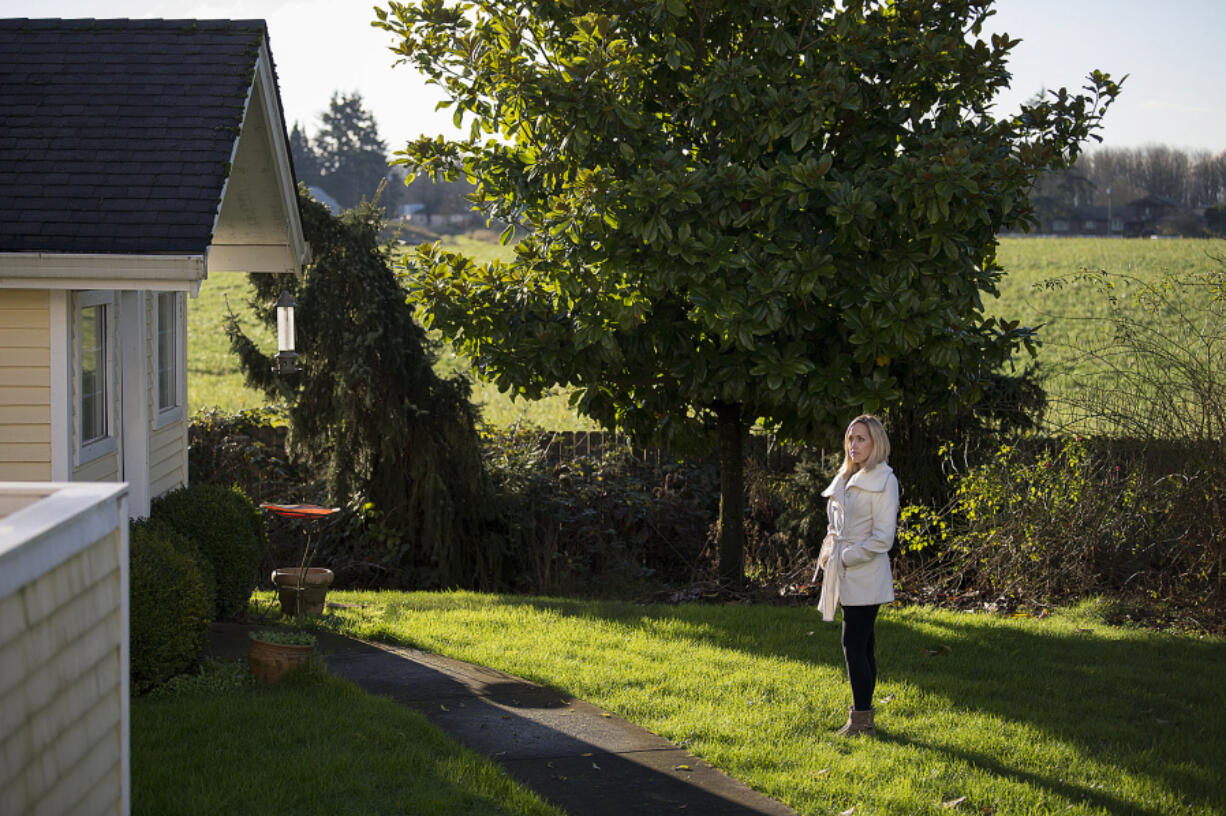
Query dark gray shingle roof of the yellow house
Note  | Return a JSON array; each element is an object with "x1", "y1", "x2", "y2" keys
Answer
[{"x1": 0, "y1": 20, "x2": 275, "y2": 255}]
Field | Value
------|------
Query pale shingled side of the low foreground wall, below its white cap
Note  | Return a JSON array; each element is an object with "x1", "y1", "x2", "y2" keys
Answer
[{"x1": 0, "y1": 531, "x2": 124, "y2": 814}]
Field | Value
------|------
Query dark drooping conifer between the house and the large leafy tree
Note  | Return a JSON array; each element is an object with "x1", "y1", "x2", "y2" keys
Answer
[{"x1": 227, "y1": 189, "x2": 501, "y2": 588}]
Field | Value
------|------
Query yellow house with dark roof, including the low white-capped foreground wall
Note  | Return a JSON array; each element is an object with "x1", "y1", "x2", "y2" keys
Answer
[{"x1": 0, "y1": 20, "x2": 308, "y2": 815}]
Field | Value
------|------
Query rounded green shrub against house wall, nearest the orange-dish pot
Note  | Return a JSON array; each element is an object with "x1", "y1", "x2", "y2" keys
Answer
[{"x1": 150, "y1": 484, "x2": 265, "y2": 618}]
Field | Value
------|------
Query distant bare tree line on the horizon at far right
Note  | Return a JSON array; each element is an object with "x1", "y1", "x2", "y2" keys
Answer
[{"x1": 1032, "y1": 145, "x2": 1226, "y2": 233}]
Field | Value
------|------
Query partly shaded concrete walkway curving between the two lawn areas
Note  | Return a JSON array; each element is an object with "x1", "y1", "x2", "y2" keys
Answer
[{"x1": 207, "y1": 624, "x2": 794, "y2": 816}]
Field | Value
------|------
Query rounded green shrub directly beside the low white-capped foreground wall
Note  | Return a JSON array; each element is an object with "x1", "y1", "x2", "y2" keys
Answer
[{"x1": 129, "y1": 521, "x2": 212, "y2": 693}]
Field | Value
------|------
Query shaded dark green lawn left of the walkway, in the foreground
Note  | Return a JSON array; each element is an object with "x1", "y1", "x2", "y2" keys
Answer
[{"x1": 131, "y1": 673, "x2": 559, "y2": 816}]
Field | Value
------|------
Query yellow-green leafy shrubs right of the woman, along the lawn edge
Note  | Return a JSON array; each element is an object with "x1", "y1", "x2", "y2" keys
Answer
[{"x1": 899, "y1": 437, "x2": 1224, "y2": 605}]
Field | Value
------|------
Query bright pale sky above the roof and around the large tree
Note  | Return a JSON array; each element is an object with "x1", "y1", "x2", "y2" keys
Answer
[{"x1": 0, "y1": 0, "x2": 1226, "y2": 154}]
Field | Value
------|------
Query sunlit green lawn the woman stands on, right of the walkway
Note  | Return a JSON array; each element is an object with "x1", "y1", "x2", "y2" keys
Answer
[{"x1": 280, "y1": 593, "x2": 1226, "y2": 816}]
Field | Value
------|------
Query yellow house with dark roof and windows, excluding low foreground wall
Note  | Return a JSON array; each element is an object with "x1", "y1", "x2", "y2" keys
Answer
[{"x1": 0, "y1": 20, "x2": 308, "y2": 517}]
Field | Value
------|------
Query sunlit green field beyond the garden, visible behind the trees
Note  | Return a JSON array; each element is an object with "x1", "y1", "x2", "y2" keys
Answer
[{"x1": 188, "y1": 236, "x2": 1226, "y2": 430}]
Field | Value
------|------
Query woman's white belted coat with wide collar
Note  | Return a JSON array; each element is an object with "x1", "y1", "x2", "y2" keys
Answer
[{"x1": 818, "y1": 462, "x2": 899, "y2": 620}]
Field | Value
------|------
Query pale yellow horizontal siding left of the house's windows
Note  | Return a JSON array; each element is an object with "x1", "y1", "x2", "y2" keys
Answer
[{"x1": 0, "y1": 289, "x2": 51, "y2": 480}]
